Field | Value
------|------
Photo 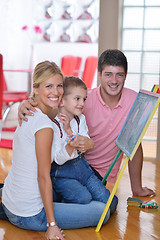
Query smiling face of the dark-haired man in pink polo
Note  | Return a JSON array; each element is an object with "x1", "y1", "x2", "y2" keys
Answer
[{"x1": 99, "y1": 65, "x2": 126, "y2": 103}]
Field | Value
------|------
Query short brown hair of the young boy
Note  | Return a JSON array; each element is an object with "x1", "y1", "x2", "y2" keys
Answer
[{"x1": 63, "y1": 76, "x2": 87, "y2": 95}]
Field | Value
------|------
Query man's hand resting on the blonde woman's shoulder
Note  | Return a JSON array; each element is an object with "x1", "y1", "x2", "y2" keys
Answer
[{"x1": 18, "y1": 99, "x2": 37, "y2": 126}]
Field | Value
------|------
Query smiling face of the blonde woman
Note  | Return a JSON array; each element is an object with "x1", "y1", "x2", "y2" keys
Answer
[{"x1": 34, "y1": 74, "x2": 63, "y2": 114}]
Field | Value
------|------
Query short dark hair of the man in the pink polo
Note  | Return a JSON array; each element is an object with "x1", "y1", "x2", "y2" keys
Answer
[{"x1": 98, "y1": 49, "x2": 128, "y2": 74}]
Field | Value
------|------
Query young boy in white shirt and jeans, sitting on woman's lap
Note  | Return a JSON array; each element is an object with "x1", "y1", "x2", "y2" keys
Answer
[{"x1": 51, "y1": 77, "x2": 118, "y2": 213}]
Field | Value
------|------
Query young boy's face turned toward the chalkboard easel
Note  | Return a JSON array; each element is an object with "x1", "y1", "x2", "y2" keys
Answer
[{"x1": 62, "y1": 86, "x2": 87, "y2": 119}]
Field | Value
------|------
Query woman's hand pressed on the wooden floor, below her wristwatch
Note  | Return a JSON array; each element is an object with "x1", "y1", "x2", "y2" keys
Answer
[{"x1": 45, "y1": 225, "x2": 65, "y2": 240}]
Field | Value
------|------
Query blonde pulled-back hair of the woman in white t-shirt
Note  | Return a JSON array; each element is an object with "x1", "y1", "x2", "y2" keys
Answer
[{"x1": 30, "y1": 61, "x2": 64, "y2": 99}]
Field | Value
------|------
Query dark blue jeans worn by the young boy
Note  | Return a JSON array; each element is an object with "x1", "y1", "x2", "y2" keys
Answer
[{"x1": 51, "y1": 155, "x2": 118, "y2": 213}]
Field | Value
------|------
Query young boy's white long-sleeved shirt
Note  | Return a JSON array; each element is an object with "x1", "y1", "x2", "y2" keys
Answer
[{"x1": 53, "y1": 114, "x2": 89, "y2": 165}]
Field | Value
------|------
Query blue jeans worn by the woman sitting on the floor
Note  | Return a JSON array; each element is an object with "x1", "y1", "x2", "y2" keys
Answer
[{"x1": 2, "y1": 201, "x2": 110, "y2": 231}]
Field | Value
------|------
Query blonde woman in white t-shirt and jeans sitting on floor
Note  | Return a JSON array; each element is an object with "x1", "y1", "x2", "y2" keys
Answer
[{"x1": 2, "y1": 61, "x2": 109, "y2": 240}]
